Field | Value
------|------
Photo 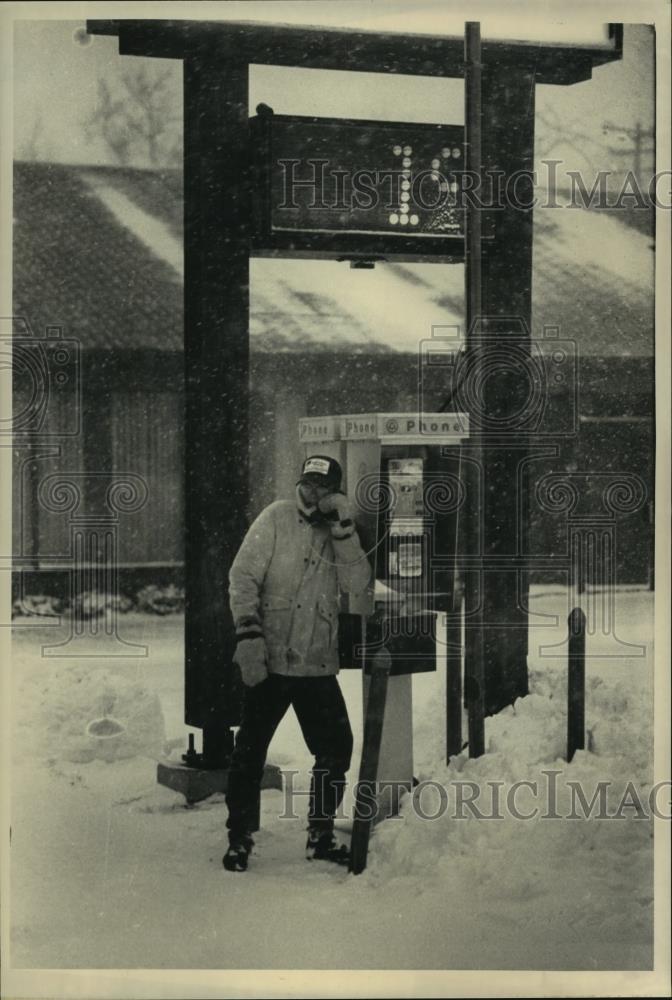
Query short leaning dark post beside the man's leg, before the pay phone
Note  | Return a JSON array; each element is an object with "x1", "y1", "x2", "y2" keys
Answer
[{"x1": 350, "y1": 647, "x2": 392, "y2": 875}]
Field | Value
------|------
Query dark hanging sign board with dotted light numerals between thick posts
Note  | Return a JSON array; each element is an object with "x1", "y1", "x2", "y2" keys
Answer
[{"x1": 250, "y1": 109, "x2": 465, "y2": 262}]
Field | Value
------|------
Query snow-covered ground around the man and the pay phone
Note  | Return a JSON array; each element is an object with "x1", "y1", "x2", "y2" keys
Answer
[{"x1": 10, "y1": 588, "x2": 669, "y2": 970}]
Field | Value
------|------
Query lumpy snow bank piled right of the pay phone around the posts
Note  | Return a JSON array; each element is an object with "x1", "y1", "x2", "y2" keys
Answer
[{"x1": 367, "y1": 656, "x2": 662, "y2": 963}]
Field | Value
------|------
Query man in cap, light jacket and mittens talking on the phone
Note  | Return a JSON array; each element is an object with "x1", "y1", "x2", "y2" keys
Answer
[{"x1": 224, "y1": 455, "x2": 371, "y2": 871}]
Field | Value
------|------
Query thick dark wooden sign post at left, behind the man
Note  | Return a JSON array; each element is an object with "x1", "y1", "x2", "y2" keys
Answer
[{"x1": 184, "y1": 56, "x2": 250, "y2": 767}]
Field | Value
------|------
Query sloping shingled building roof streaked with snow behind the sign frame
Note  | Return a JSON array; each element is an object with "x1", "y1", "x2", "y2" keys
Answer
[{"x1": 14, "y1": 163, "x2": 654, "y2": 358}]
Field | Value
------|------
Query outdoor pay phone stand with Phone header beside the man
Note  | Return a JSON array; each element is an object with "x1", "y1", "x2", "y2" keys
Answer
[{"x1": 299, "y1": 413, "x2": 468, "y2": 818}]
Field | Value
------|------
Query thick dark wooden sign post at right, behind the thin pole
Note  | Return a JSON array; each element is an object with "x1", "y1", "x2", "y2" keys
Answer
[{"x1": 477, "y1": 47, "x2": 543, "y2": 715}]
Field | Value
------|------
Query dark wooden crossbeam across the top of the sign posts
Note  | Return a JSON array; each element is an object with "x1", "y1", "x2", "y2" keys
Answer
[{"x1": 87, "y1": 19, "x2": 623, "y2": 85}]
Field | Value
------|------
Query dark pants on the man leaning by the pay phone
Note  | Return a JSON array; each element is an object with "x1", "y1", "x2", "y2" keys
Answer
[{"x1": 226, "y1": 674, "x2": 352, "y2": 835}]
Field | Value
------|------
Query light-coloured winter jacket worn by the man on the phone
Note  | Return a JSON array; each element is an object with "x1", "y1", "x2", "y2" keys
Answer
[{"x1": 229, "y1": 500, "x2": 371, "y2": 677}]
